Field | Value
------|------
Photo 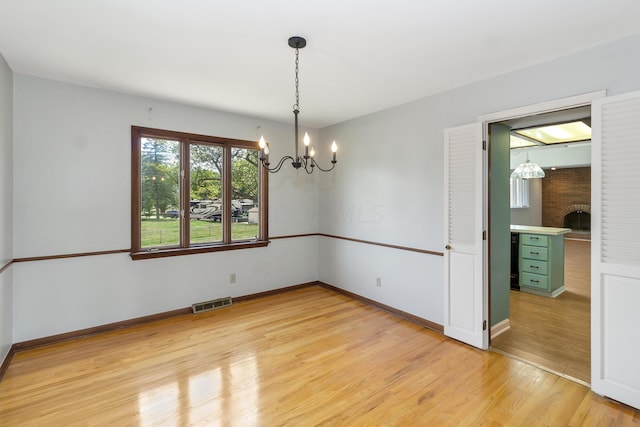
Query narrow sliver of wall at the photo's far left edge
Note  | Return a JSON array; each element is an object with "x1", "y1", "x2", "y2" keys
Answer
[{"x1": 0, "y1": 51, "x2": 13, "y2": 364}]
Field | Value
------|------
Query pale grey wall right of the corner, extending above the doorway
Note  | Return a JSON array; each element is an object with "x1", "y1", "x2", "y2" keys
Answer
[{"x1": 320, "y1": 36, "x2": 640, "y2": 323}]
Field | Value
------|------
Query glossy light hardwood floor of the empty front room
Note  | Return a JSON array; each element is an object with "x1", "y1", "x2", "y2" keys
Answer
[{"x1": 0, "y1": 287, "x2": 640, "y2": 426}]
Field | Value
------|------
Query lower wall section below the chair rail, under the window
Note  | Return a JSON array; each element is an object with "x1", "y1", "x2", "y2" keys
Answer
[{"x1": 14, "y1": 237, "x2": 318, "y2": 342}]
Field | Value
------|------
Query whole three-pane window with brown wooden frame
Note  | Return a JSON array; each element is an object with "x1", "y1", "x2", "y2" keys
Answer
[{"x1": 131, "y1": 126, "x2": 268, "y2": 259}]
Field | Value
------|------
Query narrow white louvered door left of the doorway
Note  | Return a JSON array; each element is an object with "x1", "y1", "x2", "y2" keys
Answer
[{"x1": 444, "y1": 123, "x2": 488, "y2": 349}]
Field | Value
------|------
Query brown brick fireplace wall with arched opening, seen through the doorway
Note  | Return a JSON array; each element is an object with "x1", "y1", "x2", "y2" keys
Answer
[{"x1": 542, "y1": 167, "x2": 591, "y2": 232}]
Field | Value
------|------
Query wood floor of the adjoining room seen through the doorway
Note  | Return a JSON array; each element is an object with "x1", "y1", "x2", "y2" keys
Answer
[{"x1": 491, "y1": 239, "x2": 591, "y2": 383}]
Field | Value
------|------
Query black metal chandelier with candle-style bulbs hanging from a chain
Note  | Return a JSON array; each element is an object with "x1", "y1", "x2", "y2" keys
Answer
[{"x1": 259, "y1": 36, "x2": 338, "y2": 174}]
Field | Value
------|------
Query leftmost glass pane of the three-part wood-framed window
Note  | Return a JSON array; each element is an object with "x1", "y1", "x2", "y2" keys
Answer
[{"x1": 140, "y1": 138, "x2": 180, "y2": 248}]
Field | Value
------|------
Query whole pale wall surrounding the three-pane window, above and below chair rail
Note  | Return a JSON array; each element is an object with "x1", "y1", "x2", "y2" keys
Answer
[{"x1": 13, "y1": 75, "x2": 318, "y2": 342}]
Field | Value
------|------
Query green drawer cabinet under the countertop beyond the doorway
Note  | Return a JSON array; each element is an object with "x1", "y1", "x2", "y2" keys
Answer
[{"x1": 519, "y1": 233, "x2": 564, "y2": 298}]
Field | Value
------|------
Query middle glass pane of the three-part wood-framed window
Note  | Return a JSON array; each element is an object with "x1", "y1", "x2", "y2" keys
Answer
[{"x1": 189, "y1": 144, "x2": 224, "y2": 244}]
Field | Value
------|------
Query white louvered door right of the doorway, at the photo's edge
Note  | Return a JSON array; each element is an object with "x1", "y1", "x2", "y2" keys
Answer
[{"x1": 591, "y1": 92, "x2": 640, "y2": 408}]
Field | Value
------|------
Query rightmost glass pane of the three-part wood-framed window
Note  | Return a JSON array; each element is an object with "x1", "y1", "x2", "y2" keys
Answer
[{"x1": 231, "y1": 148, "x2": 260, "y2": 241}]
